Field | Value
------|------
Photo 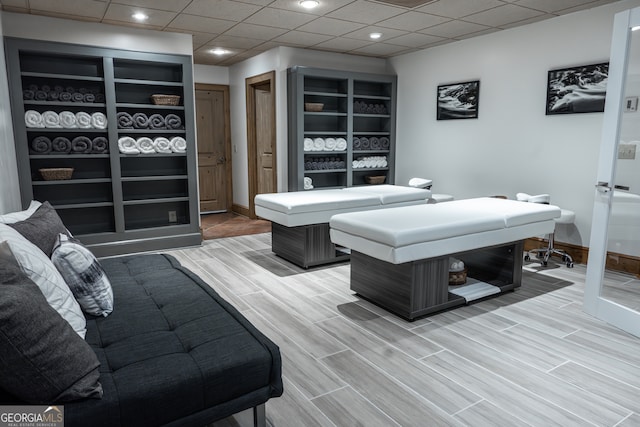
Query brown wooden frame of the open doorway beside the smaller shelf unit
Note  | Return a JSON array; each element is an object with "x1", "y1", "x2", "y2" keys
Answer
[{"x1": 245, "y1": 70, "x2": 278, "y2": 219}]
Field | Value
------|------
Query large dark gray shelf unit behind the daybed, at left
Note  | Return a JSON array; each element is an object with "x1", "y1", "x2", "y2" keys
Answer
[{"x1": 5, "y1": 38, "x2": 202, "y2": 256}]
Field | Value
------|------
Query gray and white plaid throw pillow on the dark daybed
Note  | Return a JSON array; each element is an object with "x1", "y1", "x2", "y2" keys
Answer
[{"x1": 51, "y1": 233, "x2": 113, "y2": 316}]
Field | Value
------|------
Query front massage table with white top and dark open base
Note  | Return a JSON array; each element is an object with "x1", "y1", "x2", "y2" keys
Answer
[{"x1": 329, "y1": 197, "x2": 560, "y2": 320}]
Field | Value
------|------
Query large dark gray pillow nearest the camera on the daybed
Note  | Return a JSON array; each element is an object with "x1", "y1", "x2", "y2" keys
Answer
[{"x1": 0, "y1": 244, "x2": 102, "y2": 404}]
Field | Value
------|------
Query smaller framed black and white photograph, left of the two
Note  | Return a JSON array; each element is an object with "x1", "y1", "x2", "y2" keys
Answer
[{"x1": 437, "y1": 80, "x2": 480, "y2": 120}]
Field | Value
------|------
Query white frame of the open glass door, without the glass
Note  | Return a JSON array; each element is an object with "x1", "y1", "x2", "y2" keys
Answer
[{"x1": 583, "y1": 8, "x2": 640, "y2": 337}]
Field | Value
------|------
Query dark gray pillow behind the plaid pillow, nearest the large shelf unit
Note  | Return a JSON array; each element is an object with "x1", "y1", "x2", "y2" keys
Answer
[{"x1": 9, "y1": 202, "x2": 67, "y2": 258}]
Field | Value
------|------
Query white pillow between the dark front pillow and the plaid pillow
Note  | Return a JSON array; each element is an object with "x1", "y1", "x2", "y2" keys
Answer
[{"x1": 0, "y1": 224, "x2": 87, "y2": 338}]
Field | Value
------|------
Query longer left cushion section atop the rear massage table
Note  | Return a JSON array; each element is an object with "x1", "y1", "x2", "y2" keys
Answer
[{"x1": 255, "y1": 189, "x2": 380, "y2": 215}]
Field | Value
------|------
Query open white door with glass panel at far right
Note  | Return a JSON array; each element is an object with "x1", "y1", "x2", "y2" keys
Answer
[{"x1": 584, "y1": 8, "x2": 640, "y2": 337}]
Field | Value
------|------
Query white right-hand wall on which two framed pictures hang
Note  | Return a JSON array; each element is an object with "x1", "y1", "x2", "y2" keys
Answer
[{"x1": 390, "y1": 0, "x2": 640, "y2": 246}]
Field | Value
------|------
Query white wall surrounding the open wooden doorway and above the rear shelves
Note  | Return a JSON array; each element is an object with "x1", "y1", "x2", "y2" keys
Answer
[{"x1": 229, "y1": 46, "x2": 388, "y2": 207}]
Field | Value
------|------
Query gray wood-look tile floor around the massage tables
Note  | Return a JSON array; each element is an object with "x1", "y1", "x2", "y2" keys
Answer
[{"x1": 168, "y1": 233, "x2": 640, "y2": 427}]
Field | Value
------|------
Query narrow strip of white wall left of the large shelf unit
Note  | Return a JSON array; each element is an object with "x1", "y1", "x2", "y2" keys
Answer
[{"x1": 0, "y1": 12, "x2": 22, "y2": 214}]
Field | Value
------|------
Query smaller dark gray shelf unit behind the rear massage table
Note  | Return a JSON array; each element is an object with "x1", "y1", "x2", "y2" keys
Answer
[{"x1": 287, "y1": 66, "x2": 397, "y2": 191}]
